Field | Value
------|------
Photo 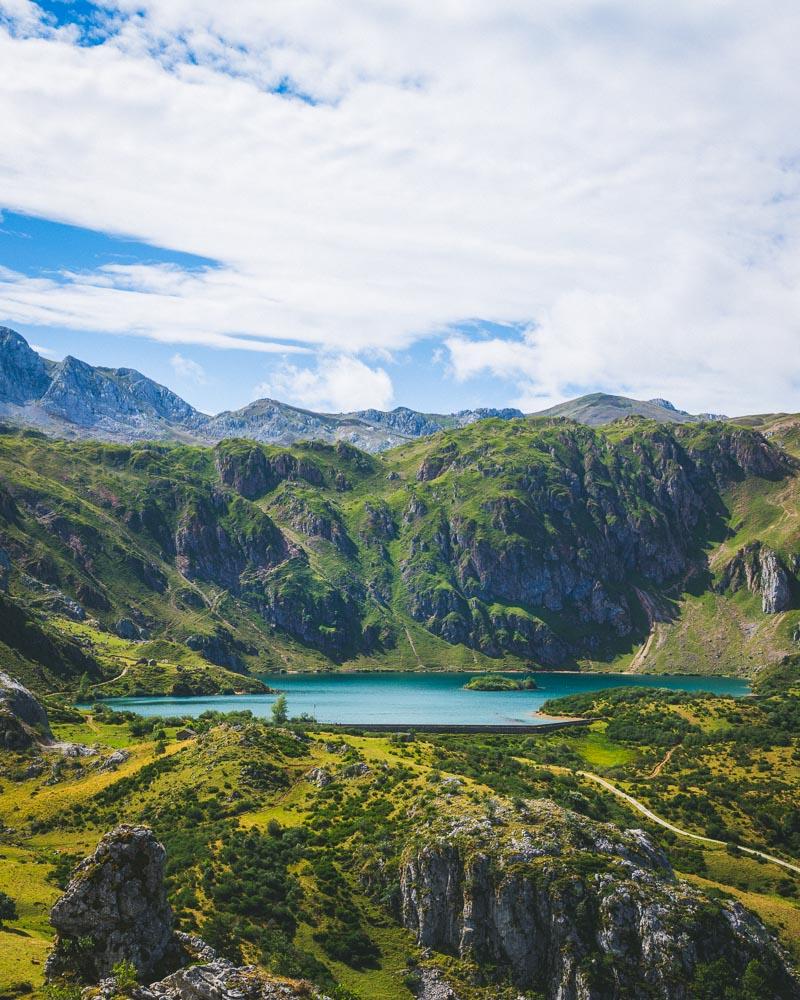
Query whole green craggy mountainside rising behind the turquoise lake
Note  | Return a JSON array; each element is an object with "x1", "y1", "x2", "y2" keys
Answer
[{"x1": 0, "y1": 418, "x2": 800, "y2": 694}]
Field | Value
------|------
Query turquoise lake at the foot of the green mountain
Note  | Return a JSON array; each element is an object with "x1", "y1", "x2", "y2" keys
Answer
[{"x1": 101, "y1": 673, "x2": 750, "y2": 725}]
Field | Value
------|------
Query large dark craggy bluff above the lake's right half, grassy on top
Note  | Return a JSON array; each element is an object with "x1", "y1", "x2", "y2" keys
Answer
[{"x1": 399, "y1": 419, "x2": 793, "y2": 666}]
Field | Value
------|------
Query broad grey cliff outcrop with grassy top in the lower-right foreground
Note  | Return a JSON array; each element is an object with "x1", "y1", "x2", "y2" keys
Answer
[{"x1": 401, "y1": 801, "x2": 800, "y2": 1000}]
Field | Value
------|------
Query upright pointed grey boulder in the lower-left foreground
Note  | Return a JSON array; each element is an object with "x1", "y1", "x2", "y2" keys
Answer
[{"x1": 47, "y1": 826, "x2": 179, "y2": 983}]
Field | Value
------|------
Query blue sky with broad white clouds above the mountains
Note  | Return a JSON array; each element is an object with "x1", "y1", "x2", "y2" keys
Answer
[{"x1": 0, "y1": 0, "x2": 800, "y2": 415}]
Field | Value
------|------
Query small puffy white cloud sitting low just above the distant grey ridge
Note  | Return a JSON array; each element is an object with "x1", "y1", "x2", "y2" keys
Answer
[{"x1": 253, "y1": 355, "x2": 393, "y2": 413}]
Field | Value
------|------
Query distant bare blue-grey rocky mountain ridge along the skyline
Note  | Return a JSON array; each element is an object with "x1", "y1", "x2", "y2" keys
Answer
[{"x1": 0, "y1": 327, "x2": 725, "y2": 452}]
